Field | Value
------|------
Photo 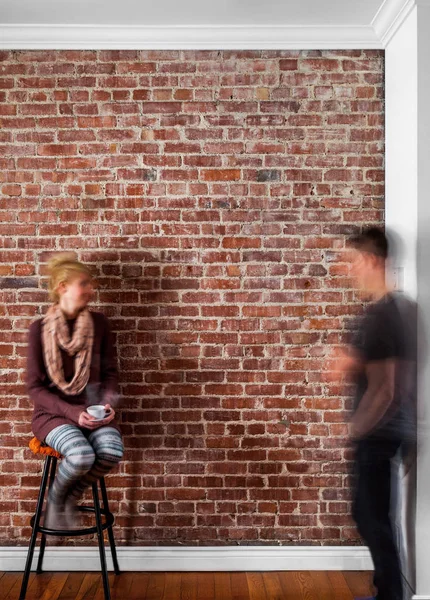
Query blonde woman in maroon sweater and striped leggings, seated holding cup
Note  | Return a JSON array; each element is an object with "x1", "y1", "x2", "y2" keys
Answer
[{"x1": 27, "y1": 253, "x2": 123, "y2": 527}]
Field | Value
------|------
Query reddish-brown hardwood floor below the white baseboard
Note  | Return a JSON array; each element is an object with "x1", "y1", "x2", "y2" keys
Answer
[{"x1": 0, "y1": 571, "x2": 371, "y2": 600}]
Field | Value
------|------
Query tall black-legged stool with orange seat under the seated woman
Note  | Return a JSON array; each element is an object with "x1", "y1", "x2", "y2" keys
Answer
[{"x1": 19, "y1": 438, "x2": 120, "y2": 600}]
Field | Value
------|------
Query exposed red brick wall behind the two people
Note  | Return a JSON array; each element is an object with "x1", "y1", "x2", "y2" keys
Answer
[{"x1": 0, "y1": 51, "x2": 384, "y2": 544}]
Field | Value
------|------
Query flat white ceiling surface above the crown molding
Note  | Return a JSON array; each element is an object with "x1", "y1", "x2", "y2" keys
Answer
[{"x1": 0, "y1": 0, "x2": 384, "y2": 27}]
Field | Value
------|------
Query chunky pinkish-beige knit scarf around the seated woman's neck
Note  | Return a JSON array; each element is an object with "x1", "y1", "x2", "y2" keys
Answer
[{"x1": 42, "y1": 304, "x2": 94, "y2": 396}]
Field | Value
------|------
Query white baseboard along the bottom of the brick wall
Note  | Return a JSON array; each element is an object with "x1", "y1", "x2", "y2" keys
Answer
[{"x1": 0, "y1": 541, "x2": 372, "y2": 572}]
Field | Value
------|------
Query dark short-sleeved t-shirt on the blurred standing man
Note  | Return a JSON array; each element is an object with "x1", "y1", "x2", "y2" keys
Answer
[{"x1": 353, "y1": 293, "x2": 416, "y2": 441}]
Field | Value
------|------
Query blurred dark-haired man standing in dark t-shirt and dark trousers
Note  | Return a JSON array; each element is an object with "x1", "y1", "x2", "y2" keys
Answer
[{"x1": 341, "y1": 228, "x2": 416, "y2": 600}]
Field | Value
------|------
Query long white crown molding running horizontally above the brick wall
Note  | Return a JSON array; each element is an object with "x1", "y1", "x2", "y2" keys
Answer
[{"x1": 0, "y1": 24, "x2": 382, "y2": 50}]
